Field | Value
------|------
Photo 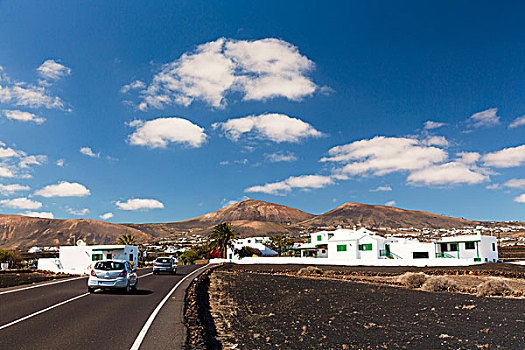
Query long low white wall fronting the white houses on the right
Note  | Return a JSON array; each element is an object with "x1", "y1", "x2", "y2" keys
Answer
[{"x1": 210, "y1": 257, "x2": 474, "y2": 267}]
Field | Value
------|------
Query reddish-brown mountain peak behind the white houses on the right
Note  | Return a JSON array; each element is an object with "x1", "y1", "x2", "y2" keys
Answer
[{"x1": 300, "y1": 203, "x2": 475, "y2": 228}]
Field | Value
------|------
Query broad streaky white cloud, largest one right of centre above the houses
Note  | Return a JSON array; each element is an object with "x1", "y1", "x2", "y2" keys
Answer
[{"x1": 321, "y1": 136, "x2": 447, "y2": 176}]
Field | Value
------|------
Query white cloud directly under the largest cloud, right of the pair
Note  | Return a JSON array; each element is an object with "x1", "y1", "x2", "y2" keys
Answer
[{"x1": 212, "y1": 113, "x2": 323, "y2": 142}]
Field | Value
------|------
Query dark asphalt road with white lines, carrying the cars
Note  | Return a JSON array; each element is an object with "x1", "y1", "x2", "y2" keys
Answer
[{"x1": 0, "y1": 265, "x2": 209, "y2": 350}]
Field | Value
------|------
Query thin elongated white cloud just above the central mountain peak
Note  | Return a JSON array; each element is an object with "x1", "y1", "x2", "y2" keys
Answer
[{"x1": 244, "y1": 175, "x2": 334, "y2": 195}]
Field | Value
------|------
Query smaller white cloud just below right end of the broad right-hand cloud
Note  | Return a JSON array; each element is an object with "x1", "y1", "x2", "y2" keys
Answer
[{"x1": 407, "y1": 162, "x2": 489, "y2": 185}]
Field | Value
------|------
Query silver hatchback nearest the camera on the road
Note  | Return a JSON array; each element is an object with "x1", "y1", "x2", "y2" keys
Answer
[{"x1": 88, "y1": 260, "x2": 138, "y2": 293}]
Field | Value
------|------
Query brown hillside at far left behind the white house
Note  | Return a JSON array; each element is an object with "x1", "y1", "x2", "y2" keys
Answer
[{"x1": 0, "y1": 214, "x2": 154, "y2": 249}]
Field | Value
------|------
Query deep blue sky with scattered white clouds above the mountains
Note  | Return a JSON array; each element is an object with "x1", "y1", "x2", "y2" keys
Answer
[{"x1": 0, "y1": 1, "x2": 525, "y2": 222}]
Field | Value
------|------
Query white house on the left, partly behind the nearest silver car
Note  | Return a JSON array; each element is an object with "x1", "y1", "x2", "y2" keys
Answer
[{"x1": 38, "y1": 245, "x2": 139, "y2": 275}]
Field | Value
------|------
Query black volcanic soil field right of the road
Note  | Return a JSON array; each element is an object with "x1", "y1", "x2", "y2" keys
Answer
[{"x1": 189, "y1": 264, "x2": 525, "y2": 349}]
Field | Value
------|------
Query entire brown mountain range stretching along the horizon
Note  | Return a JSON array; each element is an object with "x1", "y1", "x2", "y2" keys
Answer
[{"x1": 0, "y1": 199, "x2": 476, "y2": 249}]
